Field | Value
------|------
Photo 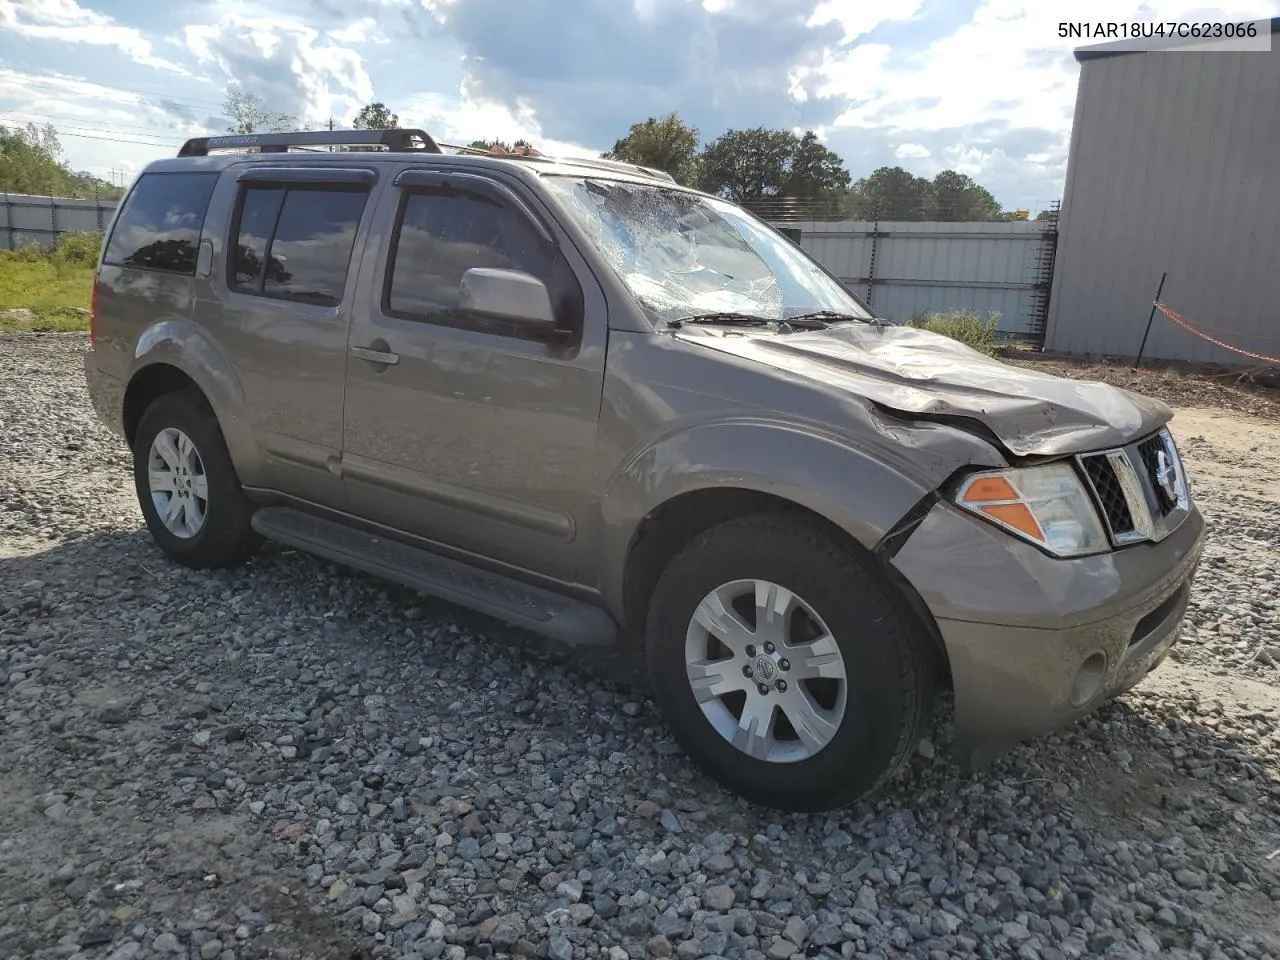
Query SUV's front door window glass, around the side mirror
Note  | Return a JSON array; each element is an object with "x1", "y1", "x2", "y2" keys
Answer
[{"x1": 385, "y1": 187, "x2": 582, "y2": 329}]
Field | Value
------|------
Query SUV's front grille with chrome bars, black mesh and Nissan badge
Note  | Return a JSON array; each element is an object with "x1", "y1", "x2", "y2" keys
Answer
[{"x1": 1078, "y1": 429, "x2": 1190, "y2": 545}]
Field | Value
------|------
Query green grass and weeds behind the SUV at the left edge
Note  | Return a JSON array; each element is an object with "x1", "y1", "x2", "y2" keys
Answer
[{"x1": 0, "y1": 233, "x2": 100, "y2": 333}]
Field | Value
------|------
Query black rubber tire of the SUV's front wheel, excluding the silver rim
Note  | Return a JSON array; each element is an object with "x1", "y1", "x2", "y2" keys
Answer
[{"x1": 646, "y1": 513, "x2": 936, "y2": 812}]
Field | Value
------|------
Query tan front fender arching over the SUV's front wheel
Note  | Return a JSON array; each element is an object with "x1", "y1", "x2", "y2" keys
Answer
[{"x1": 600, "y1": 417, "x2": 1001, "y2": 612}]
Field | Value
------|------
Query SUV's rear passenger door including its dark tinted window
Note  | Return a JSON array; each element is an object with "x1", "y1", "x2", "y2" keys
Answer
[{"x1": 197, "y1": 167, "x2": 376, "y2": 508}]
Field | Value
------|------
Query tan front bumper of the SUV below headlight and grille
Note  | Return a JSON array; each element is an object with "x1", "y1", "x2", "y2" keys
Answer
[{"x1": 893, "y1": 503, "x2": 1204, "y2": 765}]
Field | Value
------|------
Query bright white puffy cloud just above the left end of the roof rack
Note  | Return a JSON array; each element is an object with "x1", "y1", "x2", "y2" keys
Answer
[{"x1": 186, "y1": 13, "x2": 374, "y2": 123}]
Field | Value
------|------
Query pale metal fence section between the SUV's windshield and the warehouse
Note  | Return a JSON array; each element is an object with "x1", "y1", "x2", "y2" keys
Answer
[{"x1": 787, "y1": 220, "x2": 1052, "y2": 338}]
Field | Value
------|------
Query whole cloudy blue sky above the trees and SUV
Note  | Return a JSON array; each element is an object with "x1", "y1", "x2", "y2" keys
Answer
[{"x1": 0, "y1": 0, "x2": 1280, "y2": 212}]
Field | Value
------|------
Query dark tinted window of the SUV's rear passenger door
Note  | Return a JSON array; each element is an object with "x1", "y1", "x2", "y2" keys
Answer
[{"x1": 228, "y1": 186, "x2": 369, "y2": 306}]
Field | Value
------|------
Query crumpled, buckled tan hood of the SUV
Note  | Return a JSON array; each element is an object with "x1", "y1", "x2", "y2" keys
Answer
[{"x1": 676, "y1": 323, "x2": 1172, "y2": 456}]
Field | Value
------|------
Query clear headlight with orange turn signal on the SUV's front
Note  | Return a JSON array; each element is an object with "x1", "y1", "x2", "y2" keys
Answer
[{"x1": 956, "y1": 463, "x2": 1110, "y2": 557}]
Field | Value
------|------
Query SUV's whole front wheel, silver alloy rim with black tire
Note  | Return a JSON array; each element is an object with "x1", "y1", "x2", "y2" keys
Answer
[{"x1": 646, "y1": 515, "x2": 933, "y2": 812}]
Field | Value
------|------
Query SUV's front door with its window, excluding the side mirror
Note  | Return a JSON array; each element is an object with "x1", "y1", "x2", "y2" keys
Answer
[{"x1": 342, "y1": 169, "x2": 607, "y2": 582}]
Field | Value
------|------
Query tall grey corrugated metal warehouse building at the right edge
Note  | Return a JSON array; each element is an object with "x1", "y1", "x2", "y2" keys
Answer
[{"x1": 1044, "y1": 18, "x2": 1280, "y2": 364}]
